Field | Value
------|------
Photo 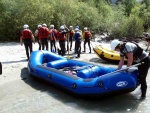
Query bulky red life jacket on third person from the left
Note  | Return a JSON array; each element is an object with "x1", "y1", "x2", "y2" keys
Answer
[{"x1": 38, "y1": 27, "x2": 50, "y2": 38}]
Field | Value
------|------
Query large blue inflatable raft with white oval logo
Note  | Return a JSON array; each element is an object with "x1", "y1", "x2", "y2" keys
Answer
[{"x1": 28, "y1": 51, "x2": 138, "y2": 96}]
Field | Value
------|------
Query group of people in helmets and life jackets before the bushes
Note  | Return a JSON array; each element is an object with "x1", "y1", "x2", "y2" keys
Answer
[{"x1": 20, "y1": 23, "x2": 92, "y2": 60}]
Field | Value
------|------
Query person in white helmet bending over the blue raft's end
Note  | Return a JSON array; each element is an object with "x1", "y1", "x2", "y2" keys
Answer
[{"x1": 111, "y1": 40, "x2": 150, "y2": 98}]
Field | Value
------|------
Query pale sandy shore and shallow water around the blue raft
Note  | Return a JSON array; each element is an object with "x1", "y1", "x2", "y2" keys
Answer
[{"x1": 0, "y1": 43, "x2": 150, "y2": 113}]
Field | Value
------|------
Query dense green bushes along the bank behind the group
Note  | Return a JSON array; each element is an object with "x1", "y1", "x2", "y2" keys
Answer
[{"x1": 0, "y1": 0, "x2": 150, "y2": 41}]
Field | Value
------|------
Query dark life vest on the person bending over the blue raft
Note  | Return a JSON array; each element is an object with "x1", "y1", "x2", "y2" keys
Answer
[{"x1": 120, "y1": 42, "x2": 143, "y2": 61}]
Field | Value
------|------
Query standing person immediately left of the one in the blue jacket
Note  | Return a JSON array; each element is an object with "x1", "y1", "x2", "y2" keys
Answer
[{"x1": 67, "y1": 26, "x2": 75, "y2": 51}]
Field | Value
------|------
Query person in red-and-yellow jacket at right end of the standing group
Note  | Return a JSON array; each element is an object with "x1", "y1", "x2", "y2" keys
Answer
[{"x1": 82, "y1": 27, "x2": 92, "y2": 53}]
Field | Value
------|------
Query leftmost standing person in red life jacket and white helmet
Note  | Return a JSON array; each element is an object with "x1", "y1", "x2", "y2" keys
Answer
[{"x1": 20, "y1": 24, "x2": 35, "y2": 60}]
